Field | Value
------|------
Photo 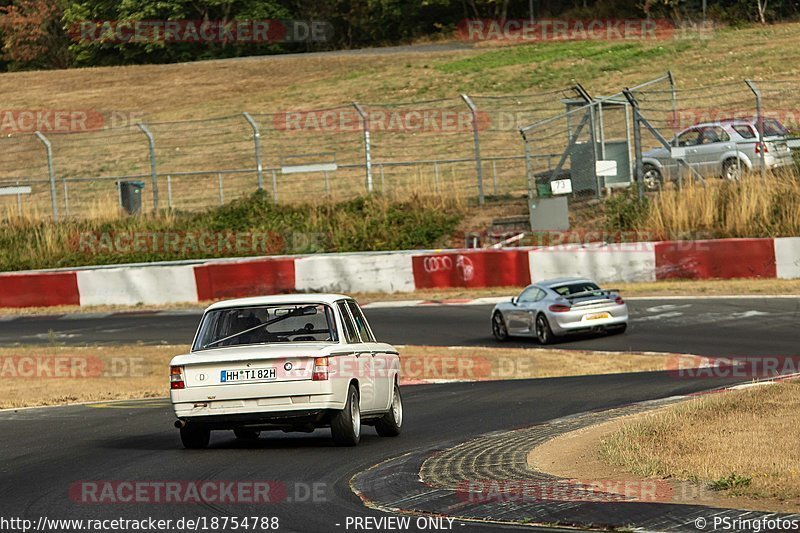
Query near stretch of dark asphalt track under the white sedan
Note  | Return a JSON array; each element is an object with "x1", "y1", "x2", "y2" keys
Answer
[{"x1": 0, "y1": 373, "x2": 752, "y2": 532}]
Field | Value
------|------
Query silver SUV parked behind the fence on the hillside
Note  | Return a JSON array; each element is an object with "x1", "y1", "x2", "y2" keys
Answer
[{"x1": 642, "y1": 118, "x2": 792, "y2": 190}]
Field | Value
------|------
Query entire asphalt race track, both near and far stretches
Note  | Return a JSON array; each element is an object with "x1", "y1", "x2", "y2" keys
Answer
[{"x1": 0, "y1": 298, "x2": 800, "y2": 532}]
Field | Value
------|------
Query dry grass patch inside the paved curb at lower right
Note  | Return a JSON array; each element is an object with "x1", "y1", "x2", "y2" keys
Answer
[{"x1": 600, "y1": 381, "x2": 800, "y2": 505}]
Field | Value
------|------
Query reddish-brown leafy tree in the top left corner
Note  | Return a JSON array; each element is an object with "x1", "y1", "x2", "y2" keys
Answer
[{"x1": 0, "y1": 0, "x2": 71, "y2": 69}]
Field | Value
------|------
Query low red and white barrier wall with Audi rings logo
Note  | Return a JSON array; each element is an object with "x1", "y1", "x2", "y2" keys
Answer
[{"x1": 0, "y1": 237, "x2": 800, "y2": 307}]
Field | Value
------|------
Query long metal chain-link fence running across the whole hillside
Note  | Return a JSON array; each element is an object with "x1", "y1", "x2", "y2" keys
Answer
[{"x1": 0, "y1": 73, "x2": 800, "y2": 219}]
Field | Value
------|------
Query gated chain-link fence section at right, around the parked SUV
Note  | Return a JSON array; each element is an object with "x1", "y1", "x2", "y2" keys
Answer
[{"x1": 520, "y1": 73, "x2": 800, "y2": 201}]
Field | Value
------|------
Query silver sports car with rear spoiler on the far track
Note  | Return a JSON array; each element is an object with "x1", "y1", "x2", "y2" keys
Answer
[{"x1": 492, "y1": 278, "x2": 628, "y2": 344}]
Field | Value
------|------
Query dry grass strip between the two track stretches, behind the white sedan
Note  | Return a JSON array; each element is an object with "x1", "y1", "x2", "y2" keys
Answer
[{"x1": 0, "y1": 345, "x2": 666, "y2": 408}]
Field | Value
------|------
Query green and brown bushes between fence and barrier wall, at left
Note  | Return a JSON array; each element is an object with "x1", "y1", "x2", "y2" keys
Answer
[{"x1": 0, "y1": 192, "x2": 463, "y2": 271}]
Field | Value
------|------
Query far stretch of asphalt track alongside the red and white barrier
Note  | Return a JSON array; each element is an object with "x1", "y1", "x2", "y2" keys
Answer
[{"x1": 0, "y1": 298, "x2": 800, "y2": 356}]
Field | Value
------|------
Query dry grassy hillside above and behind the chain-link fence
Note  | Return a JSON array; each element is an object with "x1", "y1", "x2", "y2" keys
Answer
[{"x1": 0, "y1": 24, "x2": 800, "y2": 216}]
